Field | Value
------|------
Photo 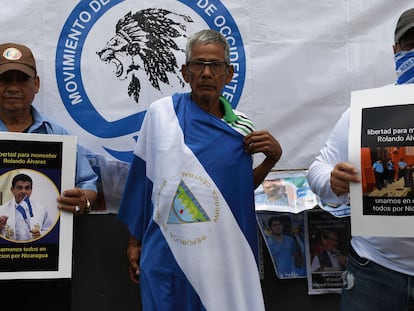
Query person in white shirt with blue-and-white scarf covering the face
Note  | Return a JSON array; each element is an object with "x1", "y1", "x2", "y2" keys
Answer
[{"x1": 308, "y1": 9, "x2": 414, "y2": 311}]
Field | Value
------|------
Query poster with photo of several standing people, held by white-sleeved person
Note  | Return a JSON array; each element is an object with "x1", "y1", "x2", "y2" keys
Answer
[{"x1": 349, "y1": 85, "x2": 414, "y2": 237}]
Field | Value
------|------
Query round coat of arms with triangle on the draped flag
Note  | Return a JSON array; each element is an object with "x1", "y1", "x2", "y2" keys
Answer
[{"x1": 154, "y1": 171, "x2": 223, "y2": 246}]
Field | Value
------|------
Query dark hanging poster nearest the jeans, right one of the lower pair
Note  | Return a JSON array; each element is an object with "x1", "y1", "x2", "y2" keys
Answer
[{"x1": 304, "y1": 209, "x2": 351, "y2": 295}]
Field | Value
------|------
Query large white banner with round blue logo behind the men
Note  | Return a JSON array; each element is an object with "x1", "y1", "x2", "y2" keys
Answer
[{"x1": 0, "y1": 0, "x2": 413, "y2": 210}]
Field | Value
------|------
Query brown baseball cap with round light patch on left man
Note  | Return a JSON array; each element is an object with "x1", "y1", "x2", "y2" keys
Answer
[{"x1": 0, "y1": 43, "x2": 36, "y2": 77}]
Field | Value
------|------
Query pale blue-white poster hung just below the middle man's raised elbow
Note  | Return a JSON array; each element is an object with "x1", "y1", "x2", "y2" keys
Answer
[{"x1": 255, "y1": 170, "x2": 319, "y2": 213}]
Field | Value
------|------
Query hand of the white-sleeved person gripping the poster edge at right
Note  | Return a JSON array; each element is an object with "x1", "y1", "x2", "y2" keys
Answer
[{"x1": 330, "y1": 162, "x2": 360, "y2": 196}]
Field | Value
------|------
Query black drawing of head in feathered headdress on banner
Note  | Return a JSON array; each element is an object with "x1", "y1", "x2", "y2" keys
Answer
[{"x1": 97, "y1": 8, "x2": 192, "y2": 103}]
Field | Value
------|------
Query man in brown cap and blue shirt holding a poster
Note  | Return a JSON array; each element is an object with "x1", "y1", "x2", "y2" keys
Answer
[{"x1": 0, "y1": 43, "x2": 98, "y2": 310}]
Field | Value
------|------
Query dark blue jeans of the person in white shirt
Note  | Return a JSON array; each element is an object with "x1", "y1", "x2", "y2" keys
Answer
[{"x1": 340, "y1": 250, "x2": 414, "y2": 311}]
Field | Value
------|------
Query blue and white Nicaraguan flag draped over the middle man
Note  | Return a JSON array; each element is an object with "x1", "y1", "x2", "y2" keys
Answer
[{"x1": 119, "y1": 94, "x2": 264, "y2": 311}]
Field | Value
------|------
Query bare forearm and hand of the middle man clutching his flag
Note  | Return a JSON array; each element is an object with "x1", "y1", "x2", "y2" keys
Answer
[{"x1": 244, "y1": 131, "x2": 282, "y2": 189}]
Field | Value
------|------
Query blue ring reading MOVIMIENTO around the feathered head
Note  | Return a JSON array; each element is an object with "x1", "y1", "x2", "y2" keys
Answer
[{"x1": 55, "y1": 0, "x2": 246, "y2": 138}]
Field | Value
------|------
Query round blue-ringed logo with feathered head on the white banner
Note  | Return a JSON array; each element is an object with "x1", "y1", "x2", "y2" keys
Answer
[{"x1": 55, "y1": 0, "x2": 246, "y2": 162}]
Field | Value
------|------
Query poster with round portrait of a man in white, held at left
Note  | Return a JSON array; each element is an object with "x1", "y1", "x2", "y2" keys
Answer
[{"x1": 0, "y1": 132, "x2": 76, "y2": 279}]
